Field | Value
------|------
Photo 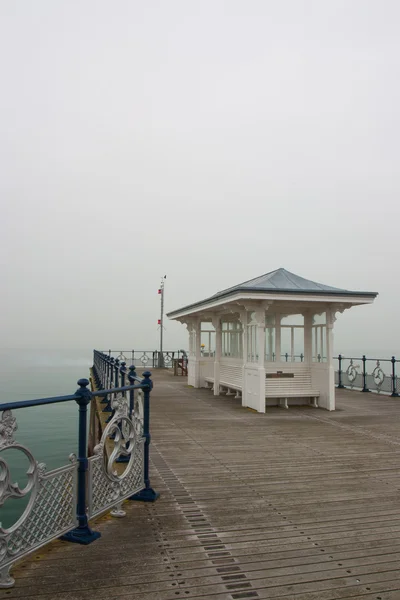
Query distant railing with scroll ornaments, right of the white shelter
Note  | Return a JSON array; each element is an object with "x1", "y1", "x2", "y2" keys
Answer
[{"x1": 334, "y1": 354, "x2": 400, "y2": 397}]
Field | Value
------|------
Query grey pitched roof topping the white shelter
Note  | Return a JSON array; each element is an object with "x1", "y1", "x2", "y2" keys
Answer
[{"x1": 167, "y1": 268, "x2": 378, "y2": 318}]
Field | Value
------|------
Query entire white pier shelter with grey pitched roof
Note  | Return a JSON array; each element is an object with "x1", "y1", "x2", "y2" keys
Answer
[{"x1": 167, "y1": 268, "x2": 377, "y2": 412}]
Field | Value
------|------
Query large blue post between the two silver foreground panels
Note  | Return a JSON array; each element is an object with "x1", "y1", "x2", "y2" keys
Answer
[{"x1": 61, "y1": 379, "x2": 101, "y2": 544}]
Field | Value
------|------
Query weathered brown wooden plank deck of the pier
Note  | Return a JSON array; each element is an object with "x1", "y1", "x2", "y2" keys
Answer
[{"x1": 5, "y1": 372, "x2": 400, "y2": 600}]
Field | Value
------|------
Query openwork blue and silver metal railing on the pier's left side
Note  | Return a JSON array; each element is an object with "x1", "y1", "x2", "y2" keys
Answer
[{"x1": 0, "y1": 351, "x2": 159, "y2": 588}]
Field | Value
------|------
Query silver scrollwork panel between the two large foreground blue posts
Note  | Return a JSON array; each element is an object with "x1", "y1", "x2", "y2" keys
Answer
[{"x1": 89, "y1": 390, "x2": 145, "y2": 518}]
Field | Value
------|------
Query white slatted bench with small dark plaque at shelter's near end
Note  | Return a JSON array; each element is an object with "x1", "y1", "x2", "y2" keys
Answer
[{"x1": 265, "y1": 371, "x2": 320, "y2": 408}]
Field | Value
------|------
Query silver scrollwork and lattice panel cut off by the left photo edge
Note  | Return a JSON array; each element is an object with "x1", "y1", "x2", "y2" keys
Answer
[{"x1": 0, "y1": 410, "x2": 77, "y2": 587}]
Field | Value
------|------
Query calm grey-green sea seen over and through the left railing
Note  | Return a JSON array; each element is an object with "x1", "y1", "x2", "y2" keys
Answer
[{"x1": 0, "y1": 350, "x2": 92, "y2": 527}]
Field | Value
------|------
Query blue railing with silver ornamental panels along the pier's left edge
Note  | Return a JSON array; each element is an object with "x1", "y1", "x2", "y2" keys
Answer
[{"x1": 0, "y1": 351, "x2": 158, "y2": 588}]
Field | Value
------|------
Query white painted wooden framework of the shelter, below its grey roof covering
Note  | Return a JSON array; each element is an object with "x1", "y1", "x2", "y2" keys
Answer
[{"x1": 171, "y1": 270, "x2": 374, "y2": 412}]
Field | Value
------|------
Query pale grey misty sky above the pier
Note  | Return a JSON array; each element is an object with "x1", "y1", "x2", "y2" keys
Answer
[{"x1": 0, "y1": 0, "x2": 400, "y2": 355}]
